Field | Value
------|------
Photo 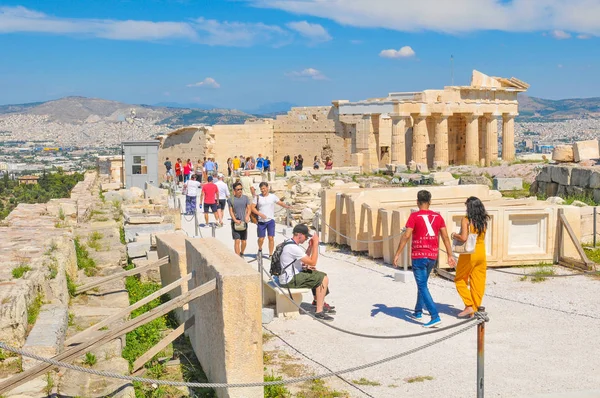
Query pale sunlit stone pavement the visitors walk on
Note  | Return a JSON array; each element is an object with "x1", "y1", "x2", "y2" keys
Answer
[{"x1": 177, "y1": 197, "x2": 600, "y2": 398}]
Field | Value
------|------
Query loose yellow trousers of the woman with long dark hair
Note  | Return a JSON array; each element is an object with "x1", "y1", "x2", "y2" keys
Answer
[{"x1": 454, "y1": 249, "x2": 487, "y2": 311}]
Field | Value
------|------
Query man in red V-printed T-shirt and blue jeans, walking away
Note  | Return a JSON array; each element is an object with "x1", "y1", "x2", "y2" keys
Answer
[{"x1": 394, "y1": 190, "x2": 456, "y2": 328}]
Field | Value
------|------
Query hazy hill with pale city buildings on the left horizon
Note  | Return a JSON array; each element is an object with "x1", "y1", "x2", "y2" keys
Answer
[{"x1": 0, "y1": 97, "x2": 255, "y2": 148}]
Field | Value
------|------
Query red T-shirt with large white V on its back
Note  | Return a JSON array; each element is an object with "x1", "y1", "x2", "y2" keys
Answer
[{"x1": 406, "y1": 210, "x2": 446, "y2": 259}]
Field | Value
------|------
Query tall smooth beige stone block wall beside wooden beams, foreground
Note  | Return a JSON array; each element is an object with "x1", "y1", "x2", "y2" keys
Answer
[{"x1": 157, "y1": 235, "x2": 263, "y2": 398}]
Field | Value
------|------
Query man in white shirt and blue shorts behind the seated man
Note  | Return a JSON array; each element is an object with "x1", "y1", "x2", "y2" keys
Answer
[{"x1": 251, "y1": 181, "x2": 290, "y2": 260}]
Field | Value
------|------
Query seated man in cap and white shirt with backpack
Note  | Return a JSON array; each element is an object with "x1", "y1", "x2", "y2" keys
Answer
[{"x1": 279, "y1": 224, "x2": 335, "y2": 321}]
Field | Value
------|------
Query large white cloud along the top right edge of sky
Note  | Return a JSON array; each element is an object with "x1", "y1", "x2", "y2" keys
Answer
[{"x1": 245, "y1": 0, "x2": 600, "y2": 36}]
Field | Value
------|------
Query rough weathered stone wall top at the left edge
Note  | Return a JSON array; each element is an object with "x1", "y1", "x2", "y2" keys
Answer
[{"x1": 0, "y1": 173, "x2": 96, "y2": 346}]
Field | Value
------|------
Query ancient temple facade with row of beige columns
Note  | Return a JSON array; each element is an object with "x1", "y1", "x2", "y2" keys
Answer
[{"x1": 333, "y1": 71, "x2": 529, "y2": 169}]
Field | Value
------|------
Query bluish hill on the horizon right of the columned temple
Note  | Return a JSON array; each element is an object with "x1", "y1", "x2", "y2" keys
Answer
[{"x1": 518, "y1": 94, "x2": 600, "y2": 122}]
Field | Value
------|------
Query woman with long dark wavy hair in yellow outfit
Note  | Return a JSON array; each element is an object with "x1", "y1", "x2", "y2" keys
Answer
[{"x1": 451, "y1": 196, "x2": 490, "y2": 318}]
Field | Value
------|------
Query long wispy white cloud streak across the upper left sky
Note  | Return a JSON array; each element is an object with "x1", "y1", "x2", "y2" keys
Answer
[{"x1": 0, "y1": 6, "x2": 292, "y2": 47}]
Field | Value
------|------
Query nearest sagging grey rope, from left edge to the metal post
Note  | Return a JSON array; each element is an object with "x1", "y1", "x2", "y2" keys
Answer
[{"x1": 0, "y1": 318, "x2": 487, "y2": 388}]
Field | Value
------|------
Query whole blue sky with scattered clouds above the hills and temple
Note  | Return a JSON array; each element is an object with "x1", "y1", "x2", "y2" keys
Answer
[{"x1": 0, "y1": 0, "x2": 600, "y2": 109}]
